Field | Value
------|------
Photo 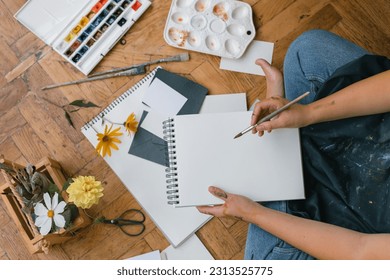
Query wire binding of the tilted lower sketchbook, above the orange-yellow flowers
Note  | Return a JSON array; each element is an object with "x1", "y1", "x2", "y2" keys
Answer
[{"x1": 81, "y1": 66, "x2": 162, "y2": 130}]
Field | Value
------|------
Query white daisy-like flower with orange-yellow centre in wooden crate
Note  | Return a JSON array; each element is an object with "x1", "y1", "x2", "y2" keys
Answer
[{"x1": 34, "y1": 193, "x2": 66, "y2": 235}]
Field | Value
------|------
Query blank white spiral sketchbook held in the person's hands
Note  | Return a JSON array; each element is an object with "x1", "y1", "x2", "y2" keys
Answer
[{"x1": 164, "y1": 112, "x2": 304, "y2": 209}]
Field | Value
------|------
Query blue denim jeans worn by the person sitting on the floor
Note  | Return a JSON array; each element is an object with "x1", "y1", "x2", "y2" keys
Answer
[{"x1": 244, "y1": 30, "x2": 368, "y2": 260}]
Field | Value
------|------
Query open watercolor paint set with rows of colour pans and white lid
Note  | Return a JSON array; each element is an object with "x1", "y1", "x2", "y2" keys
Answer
[{"x1": 15, "y1": 0, "x2": 151, "y2": 75}]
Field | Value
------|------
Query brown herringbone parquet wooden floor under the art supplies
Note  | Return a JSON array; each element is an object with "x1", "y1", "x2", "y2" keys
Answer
[{"x1": 0, "y1": 0, "x2": 390, "y2": 260}]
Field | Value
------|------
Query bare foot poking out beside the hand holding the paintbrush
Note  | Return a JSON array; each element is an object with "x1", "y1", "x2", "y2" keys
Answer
[{"x1": 256, "y1": 59, "x2": 284, "y2": 98}]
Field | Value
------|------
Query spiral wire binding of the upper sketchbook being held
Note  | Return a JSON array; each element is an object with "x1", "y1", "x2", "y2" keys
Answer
[{"x1": 163, "y1": 118, "x2": 179, "y2": 205}]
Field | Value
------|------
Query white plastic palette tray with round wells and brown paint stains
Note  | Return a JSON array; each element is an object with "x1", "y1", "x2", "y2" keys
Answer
[{"x1": 164, "y1": 0, "x2": 256, "y2": 58}]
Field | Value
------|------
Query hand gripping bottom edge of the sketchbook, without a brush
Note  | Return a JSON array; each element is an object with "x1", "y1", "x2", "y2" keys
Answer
[{"x1": 197, "y1": 187, "x2": 262, "y2": 222}]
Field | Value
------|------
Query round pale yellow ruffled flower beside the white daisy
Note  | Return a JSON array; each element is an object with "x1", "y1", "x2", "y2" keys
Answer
[{"x1": 66, "y1": 176, "x2": 104, "y2": 209}]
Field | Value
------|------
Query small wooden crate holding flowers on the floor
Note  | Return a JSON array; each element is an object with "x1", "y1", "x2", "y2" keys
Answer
[{"x1": 0, "y1": 158, "x2": 91, "y2": 254}]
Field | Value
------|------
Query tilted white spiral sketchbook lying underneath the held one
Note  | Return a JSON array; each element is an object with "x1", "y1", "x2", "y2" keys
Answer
[{"x1": 81, "y1": 67, "x2": 246, "y2": 247}]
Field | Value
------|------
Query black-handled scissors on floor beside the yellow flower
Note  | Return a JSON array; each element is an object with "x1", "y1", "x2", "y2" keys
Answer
[{"x1": 101, "y1": 209, "x2": 145, "y2": 236}]
